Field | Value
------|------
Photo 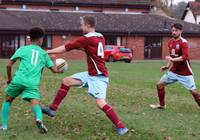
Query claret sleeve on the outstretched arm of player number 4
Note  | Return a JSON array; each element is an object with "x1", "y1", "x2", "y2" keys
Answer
[{"x1": 65, "y1": 36, "x2": 88, "y2": 51}]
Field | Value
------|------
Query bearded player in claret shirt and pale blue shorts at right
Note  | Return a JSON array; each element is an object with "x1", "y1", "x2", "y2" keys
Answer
[{"x1": 150, "y1": 23, "x2": 200, "y2": 109}]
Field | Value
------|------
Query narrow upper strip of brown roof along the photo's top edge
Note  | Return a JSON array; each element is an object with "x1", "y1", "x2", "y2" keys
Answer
[{"x1": 1, "y1": 0, "x2": 152, "y2": 8}]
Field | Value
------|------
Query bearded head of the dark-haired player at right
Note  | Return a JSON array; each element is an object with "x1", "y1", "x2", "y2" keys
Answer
[{"x1": 171, "y1": 23, "x2": 183, "y2": 39}]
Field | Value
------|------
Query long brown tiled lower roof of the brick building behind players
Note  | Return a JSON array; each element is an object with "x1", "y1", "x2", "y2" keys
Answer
[{"x1": 0, "y1": 10, "x2": 200, "y2": 36}]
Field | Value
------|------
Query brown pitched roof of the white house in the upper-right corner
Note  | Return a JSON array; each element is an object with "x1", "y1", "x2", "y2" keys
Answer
[{"x1": 182, "y1": 1, "x2": 200, "y2": 19}]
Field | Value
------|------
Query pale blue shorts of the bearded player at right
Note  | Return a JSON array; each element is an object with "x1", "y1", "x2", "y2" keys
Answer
[{"x1": 160, "y1": 71, "x2": 196, "y2": 90}]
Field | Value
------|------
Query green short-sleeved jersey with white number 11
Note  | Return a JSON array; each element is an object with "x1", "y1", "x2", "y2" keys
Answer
[{"x1": 10, "y1": 44, "x2": 54, "y2": 87}]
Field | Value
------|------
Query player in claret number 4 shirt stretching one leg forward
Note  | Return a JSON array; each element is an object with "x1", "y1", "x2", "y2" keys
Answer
[{"x1": 42, "y1": 16, "x2": 128, "y2": 135}]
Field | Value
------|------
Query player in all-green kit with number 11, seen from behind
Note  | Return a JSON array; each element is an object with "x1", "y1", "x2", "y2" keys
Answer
[{"x1": 0, "y1": 27, "x2": 59, "y2": 133}]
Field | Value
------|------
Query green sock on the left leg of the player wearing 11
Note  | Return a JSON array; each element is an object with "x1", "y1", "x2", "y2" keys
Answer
[{"x1": 1, "y1": 102, "x2": 11, "y2": 129}]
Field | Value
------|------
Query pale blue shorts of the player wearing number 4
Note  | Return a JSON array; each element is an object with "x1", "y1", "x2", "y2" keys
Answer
[{"x1": 72, "y1": 72, "x2": 109, "y2": 99}]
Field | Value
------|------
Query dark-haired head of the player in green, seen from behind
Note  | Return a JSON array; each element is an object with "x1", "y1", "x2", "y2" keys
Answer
[{"x1": 28, "y1": 27, "x2": 45, "y2": 46}]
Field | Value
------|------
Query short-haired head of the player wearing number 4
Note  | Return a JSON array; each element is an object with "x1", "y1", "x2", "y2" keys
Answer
[{"x1": 80, "y1": 16, "x2": 96, "y2": 33}]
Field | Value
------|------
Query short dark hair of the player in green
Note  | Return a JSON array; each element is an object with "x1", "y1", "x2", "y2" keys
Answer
[{"x1": 28, "y1": 27, "x2": 45, "y2": 41}]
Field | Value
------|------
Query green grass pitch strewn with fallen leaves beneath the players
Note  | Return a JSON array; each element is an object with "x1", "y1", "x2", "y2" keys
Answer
[{"x1": 0, "y1": 59, "x2": 200, "y2": 140}]
